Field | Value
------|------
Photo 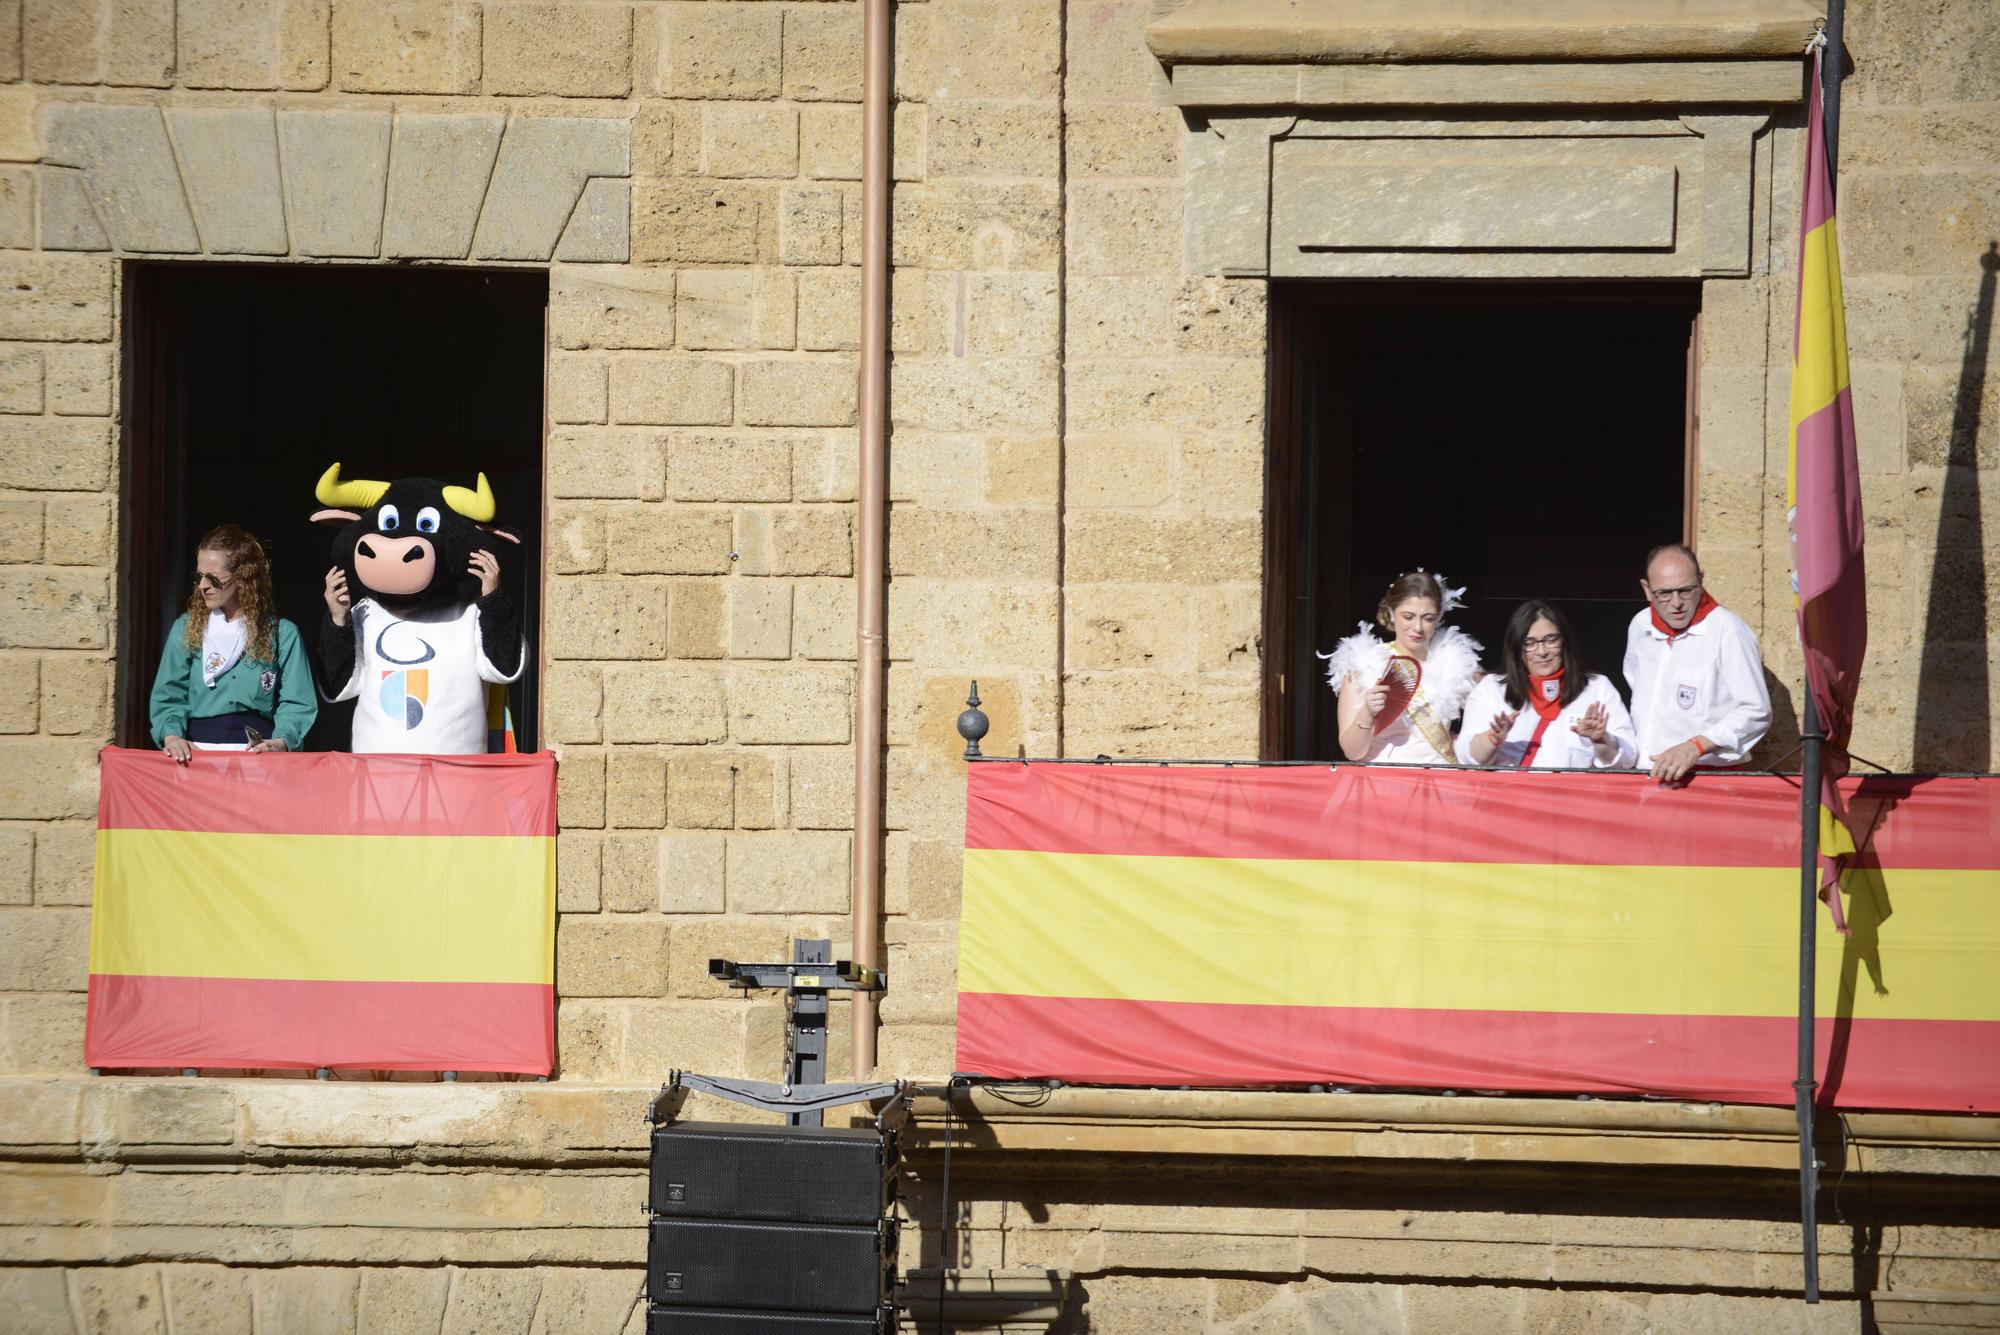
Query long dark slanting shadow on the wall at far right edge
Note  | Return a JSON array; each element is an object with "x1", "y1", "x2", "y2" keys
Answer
[{"x1": 1910, "y1": 242, "x2": 2000, "y2": 771}]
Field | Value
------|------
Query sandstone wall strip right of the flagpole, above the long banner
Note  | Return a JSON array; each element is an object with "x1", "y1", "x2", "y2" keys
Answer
[{"x1": 1824, "y1": 4, "x2": 2000, "y2": 769}]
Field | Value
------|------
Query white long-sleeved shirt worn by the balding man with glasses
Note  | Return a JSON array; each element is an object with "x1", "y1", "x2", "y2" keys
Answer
[{"x1": 1624, "y1": 606, "x2": 1770, "y2": 765}]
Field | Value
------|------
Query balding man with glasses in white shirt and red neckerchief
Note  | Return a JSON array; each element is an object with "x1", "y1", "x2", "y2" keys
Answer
[{"x1": 1624, "y1": 542, "x2": 1770, "y2": 783}]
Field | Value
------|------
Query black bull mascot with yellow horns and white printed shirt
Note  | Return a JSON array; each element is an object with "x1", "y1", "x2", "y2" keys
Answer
[{"x1": 312, "y1": 464, "x2": 528, "y2": 755}]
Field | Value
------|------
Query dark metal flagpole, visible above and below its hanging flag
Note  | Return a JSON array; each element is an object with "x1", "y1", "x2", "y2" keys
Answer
[{"x1": 1792, "y1": 0, "x2": 1846, "y2": 1303}]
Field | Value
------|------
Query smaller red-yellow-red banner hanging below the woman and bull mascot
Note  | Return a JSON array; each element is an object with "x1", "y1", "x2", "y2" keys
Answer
[{"x1": 84, "y1": 747, "x2": 556, "y2": 1075}]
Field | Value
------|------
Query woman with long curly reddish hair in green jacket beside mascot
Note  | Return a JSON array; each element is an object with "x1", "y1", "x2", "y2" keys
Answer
[{"x1": 152, "y1": 524, "x2": 320, "y2": 765}]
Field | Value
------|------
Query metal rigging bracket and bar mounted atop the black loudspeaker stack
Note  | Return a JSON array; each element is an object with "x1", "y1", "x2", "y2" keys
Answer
[{"x1": 646, "y1": 941, "x2": 902, "y2": 1127}]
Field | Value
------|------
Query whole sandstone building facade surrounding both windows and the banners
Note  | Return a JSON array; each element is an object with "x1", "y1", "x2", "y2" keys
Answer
[{"x1": 0, "y1": 0, "x2": 2000, "y2": 1333}]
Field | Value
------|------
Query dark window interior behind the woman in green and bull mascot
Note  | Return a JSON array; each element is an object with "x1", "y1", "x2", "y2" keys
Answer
[{"x1": 118, "y1": 264, "x2": 548, "y2": 751}]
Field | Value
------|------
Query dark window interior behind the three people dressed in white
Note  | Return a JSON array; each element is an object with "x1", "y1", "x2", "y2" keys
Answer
[{"x1": 1264, "y1": 282, "x2": 1698, "y2": 759}]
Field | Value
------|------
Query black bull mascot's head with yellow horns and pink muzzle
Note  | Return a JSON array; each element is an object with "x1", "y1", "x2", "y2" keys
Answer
[{"x1": 312, "y1": 464, "x2": 520, "y2": 610}]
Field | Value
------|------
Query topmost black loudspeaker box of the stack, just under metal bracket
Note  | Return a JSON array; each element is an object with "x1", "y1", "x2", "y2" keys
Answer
[{"x1": 650, "y1": 1121, "x2": 896, "y2": 1227}]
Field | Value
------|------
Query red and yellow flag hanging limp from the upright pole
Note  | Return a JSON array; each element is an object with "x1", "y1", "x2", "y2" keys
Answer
[{"x1": 1786, "y1": 36, "x2": 1868, "y2": 929}]
